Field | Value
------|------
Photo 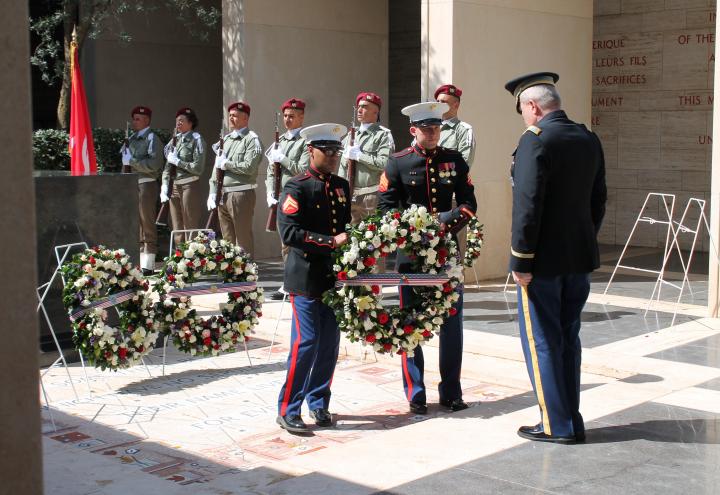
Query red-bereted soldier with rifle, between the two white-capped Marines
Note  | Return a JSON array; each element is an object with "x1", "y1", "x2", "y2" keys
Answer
[{"x1": 338, "y1": 93, "x2": 395, "y2": 224}]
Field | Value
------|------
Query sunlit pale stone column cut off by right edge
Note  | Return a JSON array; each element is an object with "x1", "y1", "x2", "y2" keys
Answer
[{"x1": 708, "y1": 4, "x2": 720, "y2": 318}]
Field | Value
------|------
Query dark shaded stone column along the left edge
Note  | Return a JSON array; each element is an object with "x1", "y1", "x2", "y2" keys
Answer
[{"x1": 0, "y1": 2, "x2": 42, "y2": 495}]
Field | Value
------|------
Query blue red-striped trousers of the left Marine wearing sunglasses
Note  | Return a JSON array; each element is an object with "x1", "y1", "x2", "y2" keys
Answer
[{"x1": 278, "y1": 294, "x2": 340, "y2": 416}]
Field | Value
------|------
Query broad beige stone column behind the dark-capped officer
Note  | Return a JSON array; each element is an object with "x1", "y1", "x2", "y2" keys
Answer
[{"x1": 421, "y1": 0, "x2": 593, "y2": 280}]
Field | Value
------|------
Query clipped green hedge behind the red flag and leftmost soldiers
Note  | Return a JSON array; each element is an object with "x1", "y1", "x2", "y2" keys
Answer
[{"x1": 33, "y1": 127, "x2": 171, "y2": 172}]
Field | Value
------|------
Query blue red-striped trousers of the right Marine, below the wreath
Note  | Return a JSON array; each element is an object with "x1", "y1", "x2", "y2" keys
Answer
[{"x1": 400, "y1": 286, "x2": 463, "y2": 404}]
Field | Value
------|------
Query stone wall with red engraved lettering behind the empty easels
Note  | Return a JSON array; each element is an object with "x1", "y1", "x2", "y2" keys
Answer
[{"x1": 592, "y1": 0, "x2": 715, "y2": 247}]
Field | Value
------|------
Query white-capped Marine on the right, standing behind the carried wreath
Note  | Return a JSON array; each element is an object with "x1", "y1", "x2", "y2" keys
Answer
[{"x1": 379, "y1": 102, "x2": 477, "y2": 414}]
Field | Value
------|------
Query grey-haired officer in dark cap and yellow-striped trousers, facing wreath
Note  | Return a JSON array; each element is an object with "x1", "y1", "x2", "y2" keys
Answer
[{"x1": 505, "y1": 72, "x2": 607, "y2": 443}]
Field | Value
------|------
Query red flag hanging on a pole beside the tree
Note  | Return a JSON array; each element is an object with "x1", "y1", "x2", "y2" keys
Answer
[{"x1": 69, "y1": 41, "x2": 97, "y2": 175}]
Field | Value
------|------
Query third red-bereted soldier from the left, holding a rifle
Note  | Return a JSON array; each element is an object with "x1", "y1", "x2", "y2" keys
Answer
[{"x1": 207, "y1": 101, "x2": 262, "y2": 256}]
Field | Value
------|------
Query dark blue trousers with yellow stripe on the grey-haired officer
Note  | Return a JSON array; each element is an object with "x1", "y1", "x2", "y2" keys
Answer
[{"x1": 518, "y1": 273, "x2": 590, "y2": 436}]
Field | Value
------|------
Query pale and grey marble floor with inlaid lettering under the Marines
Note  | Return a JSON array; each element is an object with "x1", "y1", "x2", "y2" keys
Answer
[{"x1": 42, "y1": 248, "x2": 720, "y2": 495}]
